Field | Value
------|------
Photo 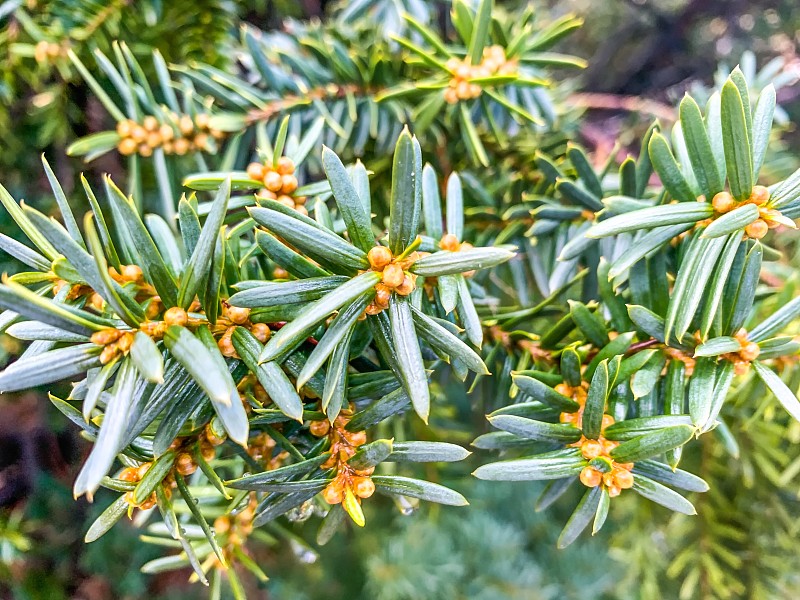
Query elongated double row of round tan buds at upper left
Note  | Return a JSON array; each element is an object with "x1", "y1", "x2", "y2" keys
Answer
[{"x1": 117, "y1": 113, "x2": 225, "y2": 157}]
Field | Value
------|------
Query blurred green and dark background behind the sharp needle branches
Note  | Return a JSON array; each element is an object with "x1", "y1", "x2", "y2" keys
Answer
[{"x1": 0, "y1": 0, "x2": 800, "y2": 600}]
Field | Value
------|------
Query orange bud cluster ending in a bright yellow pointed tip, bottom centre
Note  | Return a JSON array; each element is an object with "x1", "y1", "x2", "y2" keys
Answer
[{"x1": 309, "y1": 411, "x2": 375, "y2": 525}]
